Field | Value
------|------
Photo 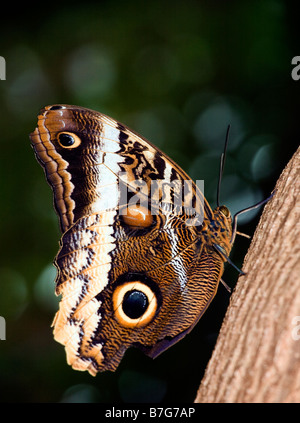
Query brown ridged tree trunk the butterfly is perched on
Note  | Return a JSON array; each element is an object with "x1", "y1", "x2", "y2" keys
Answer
[{"x1": 195, "y1": 148, "x2": 300, "y2": 403}]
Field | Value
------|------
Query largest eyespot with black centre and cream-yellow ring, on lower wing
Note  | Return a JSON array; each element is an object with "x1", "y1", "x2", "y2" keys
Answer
[{"x1": 113, "y1": 281, "x2": 158, "y2": 328}]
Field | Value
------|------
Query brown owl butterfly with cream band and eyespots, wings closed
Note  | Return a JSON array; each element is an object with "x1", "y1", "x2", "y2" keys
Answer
[{"x1": 31, "y1": 105, "x2": 253, "y2": 376}]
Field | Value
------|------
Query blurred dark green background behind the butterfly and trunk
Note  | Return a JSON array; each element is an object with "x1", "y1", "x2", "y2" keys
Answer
[{"x1": 0, "y1": 0, "x2": 300, "y2": 402}]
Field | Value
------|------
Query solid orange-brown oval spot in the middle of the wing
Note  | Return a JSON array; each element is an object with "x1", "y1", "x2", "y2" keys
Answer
[{"x1": 120, "y1": 204, "x2": 154, "y2": 228}]
